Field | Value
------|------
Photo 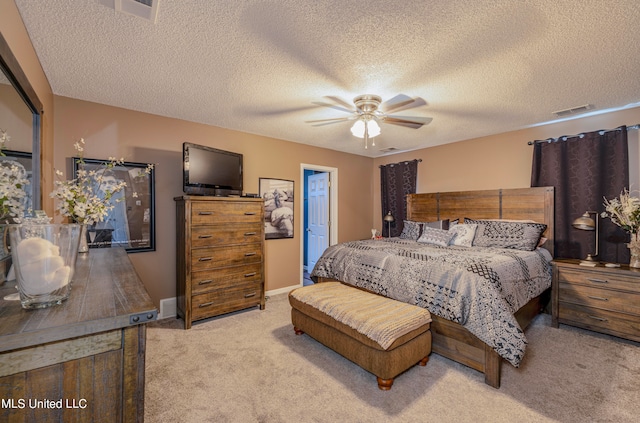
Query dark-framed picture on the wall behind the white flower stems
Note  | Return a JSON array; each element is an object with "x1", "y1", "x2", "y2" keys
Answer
[{"x1": 73, "y1": 157, "x2": 156, "y2": 253}]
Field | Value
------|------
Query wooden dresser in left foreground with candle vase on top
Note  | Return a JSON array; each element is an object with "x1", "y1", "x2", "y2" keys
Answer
[{"x1": 0, "y1": 248, "x2": 157, "y2": 422}]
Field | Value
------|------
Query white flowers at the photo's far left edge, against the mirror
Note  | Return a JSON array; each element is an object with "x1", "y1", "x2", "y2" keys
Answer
[{"x1": 0, "y1": 128, "x2": 29, "y2": 223}]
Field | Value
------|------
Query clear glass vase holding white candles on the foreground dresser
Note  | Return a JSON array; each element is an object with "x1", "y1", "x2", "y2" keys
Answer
[{"x1": 9, "y1": 224, "x2": 81, "y2": 309}]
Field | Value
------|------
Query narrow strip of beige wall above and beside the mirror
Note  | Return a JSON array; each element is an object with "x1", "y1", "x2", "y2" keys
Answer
[{"x1": 0, "y1": 0, "x2": 53, "y2": 214}]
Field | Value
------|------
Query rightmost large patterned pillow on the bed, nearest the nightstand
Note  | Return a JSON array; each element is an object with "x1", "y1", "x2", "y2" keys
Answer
[{"x1": 464, "y1": 217, "x2": 547, "y2": 251}]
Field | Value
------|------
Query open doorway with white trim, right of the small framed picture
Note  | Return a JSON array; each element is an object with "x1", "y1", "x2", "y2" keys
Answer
[{"x1": 300, "y1": 164, "x2": 338, "y2": 285}]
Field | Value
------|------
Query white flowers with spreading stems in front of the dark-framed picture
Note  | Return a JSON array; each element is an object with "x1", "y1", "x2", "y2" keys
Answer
[{"x1": 51, "y1": 138, "x2": 153, "y2": 225}]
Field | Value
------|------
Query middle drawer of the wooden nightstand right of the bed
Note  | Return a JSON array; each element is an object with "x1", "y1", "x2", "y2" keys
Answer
[{"x1": 558, "y1": 279, "x2": 640, "y2": 318}]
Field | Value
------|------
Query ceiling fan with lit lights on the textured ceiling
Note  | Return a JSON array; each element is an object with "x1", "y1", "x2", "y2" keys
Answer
[{"x1": 307, "y1": 94, "x2": 432, "y2": 148}]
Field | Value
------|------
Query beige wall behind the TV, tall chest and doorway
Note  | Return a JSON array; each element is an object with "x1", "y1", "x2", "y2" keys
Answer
[{"x1": 54, "y1": 96, "x2": 373, "y2": 305}]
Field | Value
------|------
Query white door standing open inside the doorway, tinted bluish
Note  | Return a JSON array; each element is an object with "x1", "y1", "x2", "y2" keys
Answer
[{"x1": 307, "y1": 172, "x2": 329, "y2": 272}]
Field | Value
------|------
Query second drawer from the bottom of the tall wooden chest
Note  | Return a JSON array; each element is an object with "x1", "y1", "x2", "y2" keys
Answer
[{"x1": 191, "y1": 263, "x2": 262, "y2": 295}]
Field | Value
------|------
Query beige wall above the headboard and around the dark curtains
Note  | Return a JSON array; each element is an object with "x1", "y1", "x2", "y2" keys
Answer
[{"x1": 372, "y1": 107, "x2": 640, "y2": 230}]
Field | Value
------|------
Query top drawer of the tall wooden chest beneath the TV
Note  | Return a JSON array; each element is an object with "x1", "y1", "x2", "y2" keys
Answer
[{"x1": 191, "y1": 201, "x2": 262, "y2": 225}]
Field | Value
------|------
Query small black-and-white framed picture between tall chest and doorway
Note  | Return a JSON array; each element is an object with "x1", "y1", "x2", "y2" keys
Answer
[{"x1": 260, "y1": 178, "x2": 295, "y2": 239}]
